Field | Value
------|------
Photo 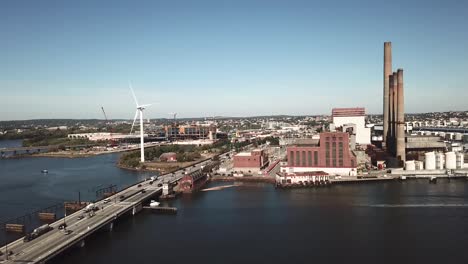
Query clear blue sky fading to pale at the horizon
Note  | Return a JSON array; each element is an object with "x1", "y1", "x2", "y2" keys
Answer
[{"x1": 0, "y1": 0, "x2": 468, "y2": 120}]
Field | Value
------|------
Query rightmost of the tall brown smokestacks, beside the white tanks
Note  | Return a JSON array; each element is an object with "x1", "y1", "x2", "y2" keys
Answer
[{"x1": 396, "y1": 69, "x2": 406, "y2": 162}]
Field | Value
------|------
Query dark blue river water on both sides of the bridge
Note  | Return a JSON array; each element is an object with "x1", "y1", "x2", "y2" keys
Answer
[{"x1": 0, "y1": 139, "x2": 468, "y2": 264}]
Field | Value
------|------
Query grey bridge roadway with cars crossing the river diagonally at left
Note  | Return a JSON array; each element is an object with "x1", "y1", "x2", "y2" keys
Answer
[{"x1": 0, "y1": 157, "x2": 216, "y2": 263}]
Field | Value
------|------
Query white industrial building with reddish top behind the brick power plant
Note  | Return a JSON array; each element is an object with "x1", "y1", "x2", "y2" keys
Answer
[{"x1": 332, "y1": 107, "x2": 371, "y2": 145}]
